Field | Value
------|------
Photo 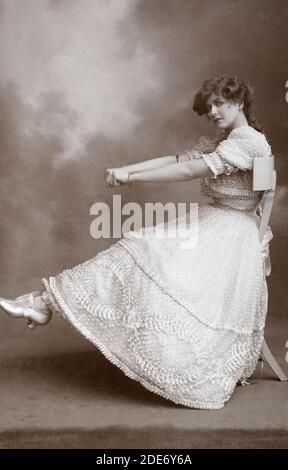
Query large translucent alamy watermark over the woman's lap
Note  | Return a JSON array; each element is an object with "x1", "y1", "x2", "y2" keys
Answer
[{"x1": 90, "y1": 194, "x2": 198, "y2": 249}]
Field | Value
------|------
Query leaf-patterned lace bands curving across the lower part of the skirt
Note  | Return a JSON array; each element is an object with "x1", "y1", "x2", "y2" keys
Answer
[{"x1": 66, "y1": 253, "x2": 263, "y2": 396}]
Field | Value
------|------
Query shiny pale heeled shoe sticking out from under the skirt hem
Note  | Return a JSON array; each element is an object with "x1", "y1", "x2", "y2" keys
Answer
[{"x1": 0, "y1": 291, "x2": 52, "y2": 330}]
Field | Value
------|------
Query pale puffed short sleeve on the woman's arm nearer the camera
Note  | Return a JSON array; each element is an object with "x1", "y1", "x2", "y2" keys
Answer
[{"x1": 201, "y1": 126, "x2": 271, "y2": 178}]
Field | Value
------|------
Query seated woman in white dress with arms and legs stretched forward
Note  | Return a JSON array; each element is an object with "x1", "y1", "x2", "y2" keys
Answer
[{"x1": 0, "y1": 76, "x2": 272, "y2": 409}]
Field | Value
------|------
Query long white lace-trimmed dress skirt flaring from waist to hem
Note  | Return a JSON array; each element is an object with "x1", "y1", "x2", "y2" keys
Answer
[{"x1": 42, "y1": 203, "x2": 272, "y2": 409}]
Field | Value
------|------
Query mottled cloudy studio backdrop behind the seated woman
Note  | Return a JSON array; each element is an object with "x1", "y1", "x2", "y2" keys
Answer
[{"x1": 0, "y1": 0, "x2": 288, "y2": 296}]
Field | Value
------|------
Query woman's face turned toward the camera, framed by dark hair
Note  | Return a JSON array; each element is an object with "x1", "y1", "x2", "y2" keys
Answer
[{"x1": 206, "y1": 93, "x2": 243, "y2": 129}]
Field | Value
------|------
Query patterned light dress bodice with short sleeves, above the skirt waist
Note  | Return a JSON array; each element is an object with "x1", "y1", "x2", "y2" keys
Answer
[{"x1": 179, "y1": 126, "x2": 272, "y2": 211}]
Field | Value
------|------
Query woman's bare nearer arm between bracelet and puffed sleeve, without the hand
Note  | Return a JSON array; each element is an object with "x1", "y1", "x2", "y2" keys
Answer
[{"x1": 129, "y1": 159, "x2": 214, "y2": 183}]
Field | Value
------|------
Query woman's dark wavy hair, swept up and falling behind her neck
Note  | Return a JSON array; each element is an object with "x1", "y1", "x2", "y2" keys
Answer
[{"x1": 193, "y1": 75, "x2": 263, "y2": 132}]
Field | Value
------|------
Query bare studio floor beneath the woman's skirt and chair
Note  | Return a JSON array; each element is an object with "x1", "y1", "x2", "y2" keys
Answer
[{"x1": 0, "y1": 276, "x2": 288, "y2": 449}]
